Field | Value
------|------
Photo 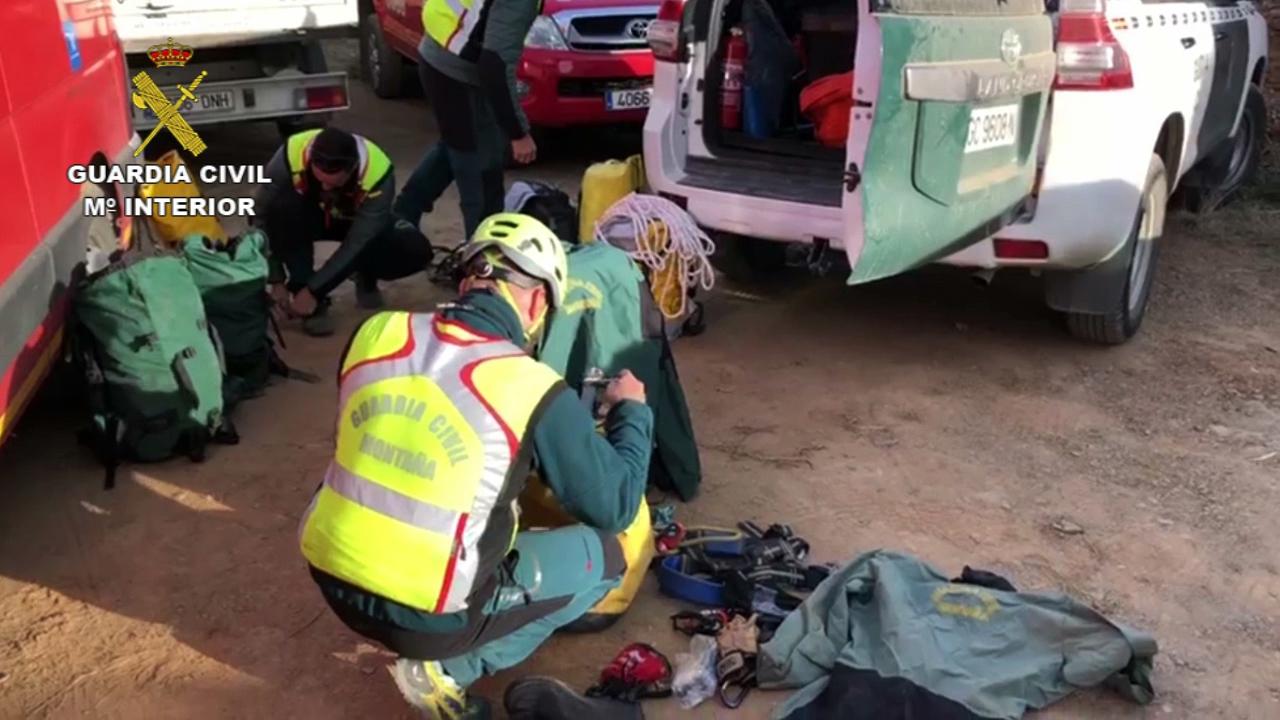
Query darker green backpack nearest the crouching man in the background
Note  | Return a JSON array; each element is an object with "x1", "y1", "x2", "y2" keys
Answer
[{"x1": 180, "y1": 231, "x2": 273, "y2": 401}]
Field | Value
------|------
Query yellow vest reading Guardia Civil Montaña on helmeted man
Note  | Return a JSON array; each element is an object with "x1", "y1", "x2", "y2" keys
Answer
[{"x1": 301, "y1": 311, "x2": 562, "y2": 614}]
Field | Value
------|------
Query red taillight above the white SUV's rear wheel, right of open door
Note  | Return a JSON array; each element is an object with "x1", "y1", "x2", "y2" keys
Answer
[{"x1": 1053, "y1": 0, "x2": 1133, "y2": 90}]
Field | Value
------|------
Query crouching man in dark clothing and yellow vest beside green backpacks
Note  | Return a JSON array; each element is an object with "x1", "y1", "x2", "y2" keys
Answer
[{"x1": 253, "y1": 128, "x2": 431, "y2": 336}]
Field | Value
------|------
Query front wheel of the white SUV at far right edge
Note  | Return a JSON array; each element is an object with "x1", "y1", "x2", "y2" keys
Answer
[{"x1": 1183, "y1": 86, "x2": 1267, "y2": 213}]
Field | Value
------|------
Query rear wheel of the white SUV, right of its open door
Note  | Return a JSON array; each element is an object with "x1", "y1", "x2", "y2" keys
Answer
[{"x1": 1066, "y1": 155, "x2": 1169, "y2": 345}]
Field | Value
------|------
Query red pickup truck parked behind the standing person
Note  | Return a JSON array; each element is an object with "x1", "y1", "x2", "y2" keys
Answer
[{"x1": 361, "y1": 0, "x2": 658, "y2": 128}]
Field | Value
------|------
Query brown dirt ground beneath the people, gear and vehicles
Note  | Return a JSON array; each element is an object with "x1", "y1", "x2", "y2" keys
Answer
[{"x1": 0, "y1": 41, "x2": 1280, "y2": 719}]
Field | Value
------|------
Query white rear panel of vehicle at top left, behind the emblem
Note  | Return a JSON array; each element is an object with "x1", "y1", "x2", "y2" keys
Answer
[{"x1": 112, "y1": 0, "x2": 360, "y2": 53}]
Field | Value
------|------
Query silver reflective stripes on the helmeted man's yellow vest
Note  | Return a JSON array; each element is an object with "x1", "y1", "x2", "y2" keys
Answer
[{"x1": 317, "y1": 314, "x2": 524, "y2": 612}]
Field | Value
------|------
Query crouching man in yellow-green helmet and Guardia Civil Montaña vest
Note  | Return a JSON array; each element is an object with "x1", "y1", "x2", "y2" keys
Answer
[{"x1": 301, "y1": 214, "x2": 653, "y2": 719}]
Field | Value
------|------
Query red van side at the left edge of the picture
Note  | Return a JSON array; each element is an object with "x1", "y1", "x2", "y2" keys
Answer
[{"x1": 0, "y1": 0, "x2": 137, "y2": 443}]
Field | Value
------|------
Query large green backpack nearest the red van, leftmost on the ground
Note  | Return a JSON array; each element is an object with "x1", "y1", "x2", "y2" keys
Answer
[{"x1": 73, "y1": 252, "x2": 238, "y2": 488}]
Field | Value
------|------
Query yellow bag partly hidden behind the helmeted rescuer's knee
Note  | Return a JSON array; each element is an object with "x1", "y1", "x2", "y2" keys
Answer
[{"x1": 520, "y1": 475, "x2": 654, "y2": 632}]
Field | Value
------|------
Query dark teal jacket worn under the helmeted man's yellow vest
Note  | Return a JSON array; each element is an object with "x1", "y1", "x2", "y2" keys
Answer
[{"x1": 309, "y1": 292, "x2": 653, "y2": 633}]
